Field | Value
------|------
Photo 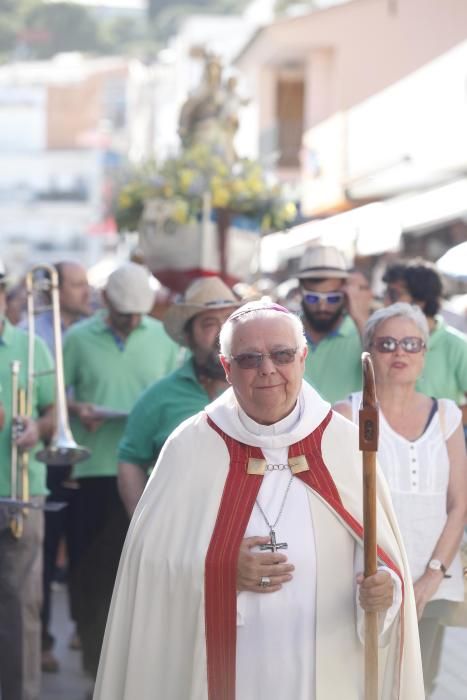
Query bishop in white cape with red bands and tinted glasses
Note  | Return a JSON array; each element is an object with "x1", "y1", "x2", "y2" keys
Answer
[{"x1": 94, "y1": 302, "x2": 424, "y2": 700}]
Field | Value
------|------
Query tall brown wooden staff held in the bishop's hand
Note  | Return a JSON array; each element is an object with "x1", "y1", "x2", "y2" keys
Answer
[{"x1": 359, "y1": 352, "x2": 378, "y2": 700}]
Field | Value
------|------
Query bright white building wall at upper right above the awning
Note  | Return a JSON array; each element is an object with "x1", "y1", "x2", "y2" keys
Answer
[{"x1": 347, "y1": 41, "x2": 467, "y2": 196}]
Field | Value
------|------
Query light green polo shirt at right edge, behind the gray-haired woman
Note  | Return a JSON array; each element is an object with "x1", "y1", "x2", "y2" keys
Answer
[{"x1": 417, "y1": 316, "x2": 467, "y2": 404}]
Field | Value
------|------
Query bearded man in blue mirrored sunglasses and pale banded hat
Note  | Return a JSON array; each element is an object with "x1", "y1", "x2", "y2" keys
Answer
[{"x1": 297, "y1": 246, "x2": 371, "y2": 403}]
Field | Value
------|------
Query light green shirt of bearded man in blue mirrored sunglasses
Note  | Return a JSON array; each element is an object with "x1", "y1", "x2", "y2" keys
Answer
[{"x1": 305, "y1": 316, "x2": 362, "y2": 404}]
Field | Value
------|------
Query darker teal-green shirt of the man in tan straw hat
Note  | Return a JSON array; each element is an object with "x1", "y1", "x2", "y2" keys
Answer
[{"x1": 118, "y1": 359, "x2": 210, "y2": 468}]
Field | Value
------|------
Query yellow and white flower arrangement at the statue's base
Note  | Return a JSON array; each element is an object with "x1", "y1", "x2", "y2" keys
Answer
[{"x1": 116, "y1": 144, "x2": 297, "y2": 233}]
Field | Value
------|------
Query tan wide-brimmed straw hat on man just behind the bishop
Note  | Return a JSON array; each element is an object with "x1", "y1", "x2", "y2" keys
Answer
[{"x1": 163, "y1": 277, "x2": 244, "y2": 345}]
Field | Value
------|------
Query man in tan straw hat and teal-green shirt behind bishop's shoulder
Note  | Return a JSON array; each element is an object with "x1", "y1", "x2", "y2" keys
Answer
[{"x1": 118, "y1": 277, "x2": 242, "y2": 517}]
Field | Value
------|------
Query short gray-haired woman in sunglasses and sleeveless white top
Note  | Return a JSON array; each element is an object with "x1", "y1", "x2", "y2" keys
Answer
[{"x1": 335, "y1": 302, "x2": 467, "y2": 697}]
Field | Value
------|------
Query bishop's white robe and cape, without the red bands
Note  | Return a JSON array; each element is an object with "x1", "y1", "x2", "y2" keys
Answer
[{"x1": 95, "y1": 383, "x2": 424, "y2": 700}]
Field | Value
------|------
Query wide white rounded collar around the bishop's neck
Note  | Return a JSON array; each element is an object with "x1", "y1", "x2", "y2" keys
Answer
[{"x1": 205, "y1": 381, "x2": 331, "y2": 449}]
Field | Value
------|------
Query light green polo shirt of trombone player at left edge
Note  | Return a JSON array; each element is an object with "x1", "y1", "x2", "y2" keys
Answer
[{"x1": 0, "y1": 320, "x2": 55, "y2": 497}]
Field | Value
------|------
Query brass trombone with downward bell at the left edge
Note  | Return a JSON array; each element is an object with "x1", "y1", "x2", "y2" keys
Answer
[{"x1": 0, "y1": 264, "x2": 90, "y2": 538}]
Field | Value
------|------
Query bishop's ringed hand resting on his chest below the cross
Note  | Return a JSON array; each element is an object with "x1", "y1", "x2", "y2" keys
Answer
[{"x1": 237, "y1": 537, "x2": 295, "y2": 593}]
